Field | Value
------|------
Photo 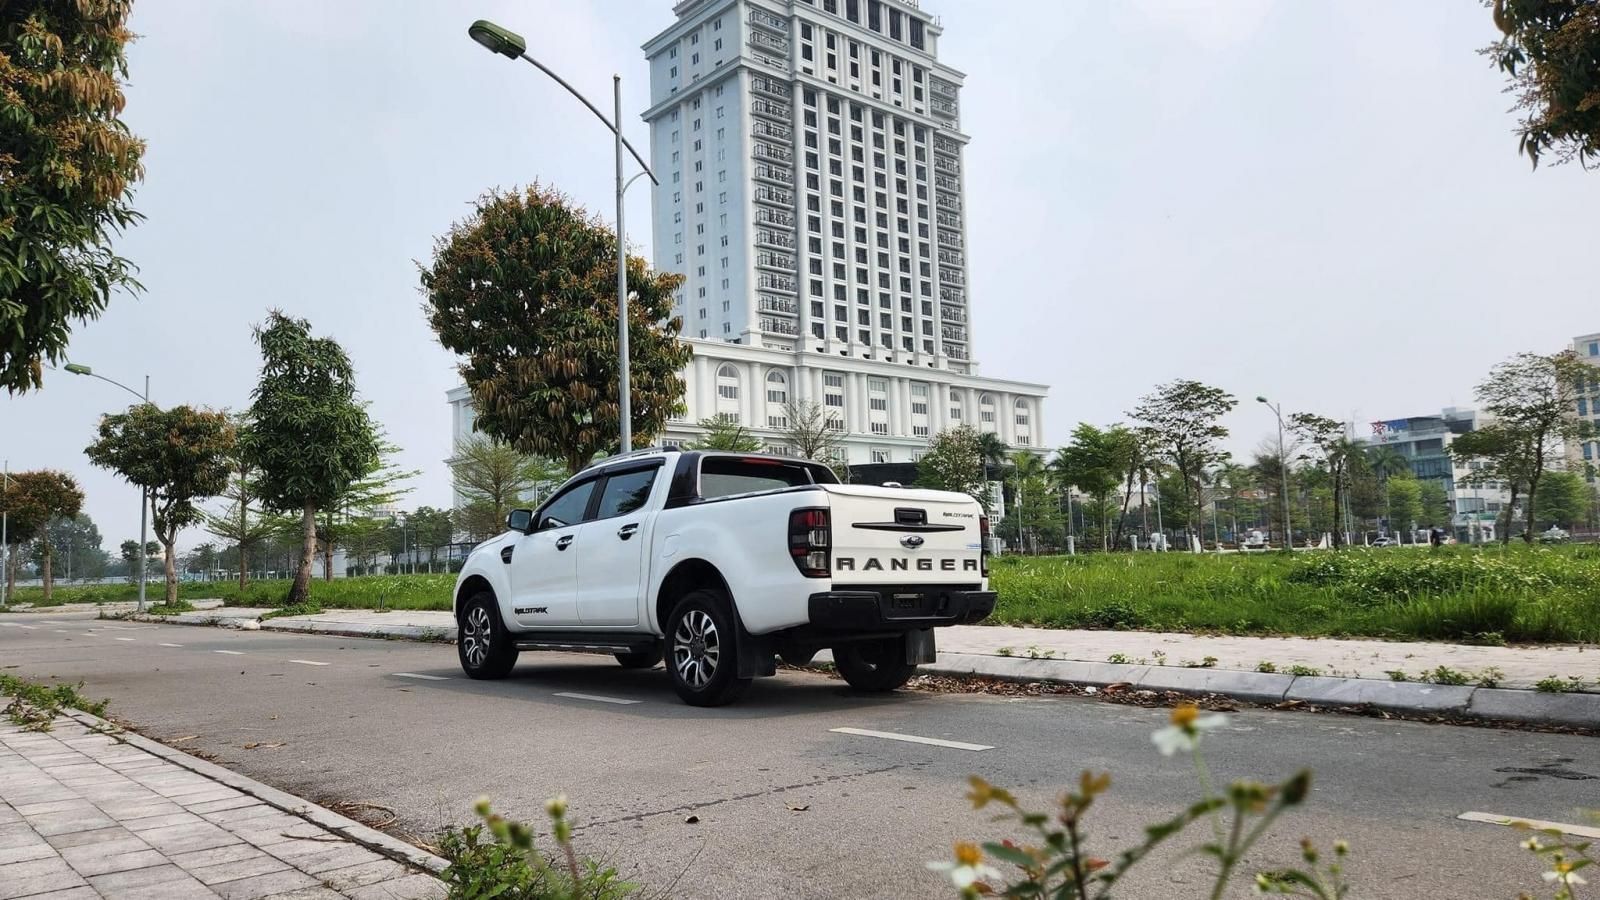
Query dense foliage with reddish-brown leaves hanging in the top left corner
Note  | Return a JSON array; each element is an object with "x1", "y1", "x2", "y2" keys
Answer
[{"x1": 0, "y1": 0, "x2": 144, "y2": 394}]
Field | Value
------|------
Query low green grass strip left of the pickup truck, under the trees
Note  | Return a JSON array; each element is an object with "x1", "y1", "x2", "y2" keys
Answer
[{"x1": 6, "y1": 573, "x2": 456, "y2": 610}]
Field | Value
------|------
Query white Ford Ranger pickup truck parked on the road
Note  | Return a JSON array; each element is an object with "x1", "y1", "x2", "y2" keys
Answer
[{"x1": 454, "y1": 450, "x2": 995, "y2": 706}]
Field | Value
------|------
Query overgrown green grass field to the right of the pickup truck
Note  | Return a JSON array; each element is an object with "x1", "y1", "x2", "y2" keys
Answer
[{"x1": 989, "y1": 546, "x2": 1600, "y2": 644}]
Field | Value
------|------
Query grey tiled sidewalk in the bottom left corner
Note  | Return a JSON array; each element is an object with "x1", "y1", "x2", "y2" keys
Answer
[{"x1": 0, "y1": 713, "x2": 445, "y2": 900}]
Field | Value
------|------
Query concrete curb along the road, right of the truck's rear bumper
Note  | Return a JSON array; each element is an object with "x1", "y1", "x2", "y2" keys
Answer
[{"x1": 922, "y1": 652, "x2": 1600, "y2": 729}]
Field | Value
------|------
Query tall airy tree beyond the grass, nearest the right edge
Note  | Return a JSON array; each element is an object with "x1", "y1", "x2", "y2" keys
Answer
[{"x1": 1451, "y1": 351, "x2": 1594, "y2": 544}]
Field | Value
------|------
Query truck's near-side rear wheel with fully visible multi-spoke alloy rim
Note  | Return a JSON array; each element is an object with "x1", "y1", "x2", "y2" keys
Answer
[{"x1": 666, "y1": 591, "x2": 750, "y2": 706}]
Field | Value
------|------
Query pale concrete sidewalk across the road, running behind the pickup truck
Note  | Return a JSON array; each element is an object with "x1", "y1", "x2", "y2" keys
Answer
[{"x1": 131, "y1": 598, "x2": 1600, "y2": 729}]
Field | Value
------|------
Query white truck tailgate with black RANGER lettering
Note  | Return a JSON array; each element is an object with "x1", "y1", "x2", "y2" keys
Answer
[{"x1": 824, "y1": 485, "x2": 982, "y2": 586}]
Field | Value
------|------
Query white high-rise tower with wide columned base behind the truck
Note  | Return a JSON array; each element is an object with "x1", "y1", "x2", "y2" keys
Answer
[{"x1": 450, "y1": 0, "x2": 1048, "y2": 464}]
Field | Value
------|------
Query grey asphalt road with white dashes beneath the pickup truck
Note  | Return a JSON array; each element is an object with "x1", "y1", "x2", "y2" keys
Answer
[{"x1": 0, "y1": 613, "x2": 1600, "y2": 898}]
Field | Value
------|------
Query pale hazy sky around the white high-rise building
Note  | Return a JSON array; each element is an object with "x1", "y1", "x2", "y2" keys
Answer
[{"x1": 0, "y1": 0, "x2": 1600, "y2": 551}]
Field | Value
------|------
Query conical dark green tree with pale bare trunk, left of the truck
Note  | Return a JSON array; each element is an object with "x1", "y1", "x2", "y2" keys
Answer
[{"x1": 250, "y1": 311, "x2": 381, "y2": 604}]
